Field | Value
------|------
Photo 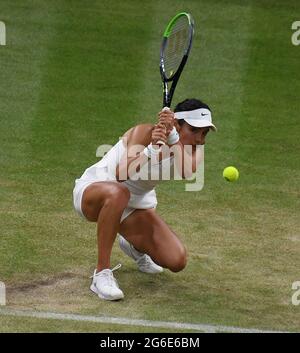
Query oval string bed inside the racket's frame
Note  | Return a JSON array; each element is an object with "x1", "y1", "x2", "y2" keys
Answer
[{"x1": 164, "y1": 17, "x2": 189, "y2": 78}]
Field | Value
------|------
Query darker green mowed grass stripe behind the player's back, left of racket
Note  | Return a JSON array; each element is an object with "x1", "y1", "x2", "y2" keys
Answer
[{"x1": 2, "y1": 1, "x2": 157, "y2": 280}]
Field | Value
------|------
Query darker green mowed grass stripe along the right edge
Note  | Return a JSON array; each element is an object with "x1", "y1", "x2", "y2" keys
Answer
[{"x1": 218, "y1": 1, "x2": 300, "y2": 329}]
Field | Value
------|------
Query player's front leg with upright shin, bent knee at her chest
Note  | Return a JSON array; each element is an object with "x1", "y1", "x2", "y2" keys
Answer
[{"x1": 81, "y1": 182, "x2": 130, "y2": 272}]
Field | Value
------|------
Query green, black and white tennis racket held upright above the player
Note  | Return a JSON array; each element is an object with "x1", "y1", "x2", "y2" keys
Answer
[{"x1": 157, "y1": 12, "x2": 194, "y2": 145}]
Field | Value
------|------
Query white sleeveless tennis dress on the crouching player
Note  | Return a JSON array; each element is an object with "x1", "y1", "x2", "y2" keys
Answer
[{"x1": 73, "y1": 140, "x2": 174, "y2": 222}]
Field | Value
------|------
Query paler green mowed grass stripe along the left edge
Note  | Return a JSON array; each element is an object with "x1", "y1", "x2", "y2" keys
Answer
[{"x1": 0, "y1": 1, "x2": 60, "y2": 280}]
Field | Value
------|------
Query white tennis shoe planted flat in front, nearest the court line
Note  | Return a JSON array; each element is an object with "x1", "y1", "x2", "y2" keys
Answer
[{"x1": 90, "y1": 264, "x2": 124, "y2": 300}]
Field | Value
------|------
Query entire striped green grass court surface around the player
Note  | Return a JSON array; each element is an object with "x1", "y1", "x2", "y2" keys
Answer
[{"x1": 0, "y1": 0, "x2": 300, "y2": 332}]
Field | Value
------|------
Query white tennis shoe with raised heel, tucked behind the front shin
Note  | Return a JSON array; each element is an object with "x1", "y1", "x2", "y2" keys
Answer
[{"x1": 119, "y1": 235, "x2": 164, "y2": 273}]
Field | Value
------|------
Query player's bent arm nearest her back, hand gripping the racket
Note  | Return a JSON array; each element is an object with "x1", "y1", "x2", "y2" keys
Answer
[{"x1": 116, "y1": 124, "x2": 167, "y2": 182}]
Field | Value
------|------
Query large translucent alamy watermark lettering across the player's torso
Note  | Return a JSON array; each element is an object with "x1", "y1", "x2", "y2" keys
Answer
[{"x1": 96, "y1": 138, "x2": 204, "y2": 191}]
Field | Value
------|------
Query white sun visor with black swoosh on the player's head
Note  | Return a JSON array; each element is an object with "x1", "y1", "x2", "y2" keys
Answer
[{"x1": 174, "y1": 108, "x2": 217, "y2": 131}]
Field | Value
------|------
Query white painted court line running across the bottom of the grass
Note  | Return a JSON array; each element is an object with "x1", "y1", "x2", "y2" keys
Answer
[{"x1": 0, "y1": 308, "x2": 286, "y2": 333}]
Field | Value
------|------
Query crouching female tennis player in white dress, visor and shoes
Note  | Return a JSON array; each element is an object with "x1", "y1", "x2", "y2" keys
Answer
[{"x1": 73, "y1": 99, "x2": 216, "y2": 300}]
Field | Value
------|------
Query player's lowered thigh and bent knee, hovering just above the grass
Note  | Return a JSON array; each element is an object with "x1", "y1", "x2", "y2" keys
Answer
[{"x1": 119, "y1": 209, "x2": 187, "y2": 272}]
